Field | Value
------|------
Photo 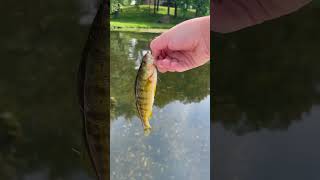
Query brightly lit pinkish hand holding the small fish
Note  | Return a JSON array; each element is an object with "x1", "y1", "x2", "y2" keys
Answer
[{"x1": 150, "y1": 16, "x2": 210, "y2": 72}]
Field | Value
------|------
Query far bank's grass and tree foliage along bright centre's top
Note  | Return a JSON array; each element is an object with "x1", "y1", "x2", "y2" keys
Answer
[{"x1": 111, "y1": 0, "x2": 210, "y2": 29}]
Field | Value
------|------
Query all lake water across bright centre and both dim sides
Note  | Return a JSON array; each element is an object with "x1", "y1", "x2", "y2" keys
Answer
[{"x1": 0, "y1": 0, "x2": 320, "y2": 180}]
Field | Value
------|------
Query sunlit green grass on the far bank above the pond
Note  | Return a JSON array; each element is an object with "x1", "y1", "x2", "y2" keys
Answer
[{"x1": 110, "y1": 5, "x2": 195, "y2": 31}]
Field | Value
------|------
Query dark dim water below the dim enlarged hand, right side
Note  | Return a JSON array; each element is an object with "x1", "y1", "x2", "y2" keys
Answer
[{"x1": 212, "y1": 3, "x2": 320, "y2": 180}]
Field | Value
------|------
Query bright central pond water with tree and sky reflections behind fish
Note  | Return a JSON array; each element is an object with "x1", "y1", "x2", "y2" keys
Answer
[{"x1": 110, "y1": 32, "x2": 210, "y2": 180}]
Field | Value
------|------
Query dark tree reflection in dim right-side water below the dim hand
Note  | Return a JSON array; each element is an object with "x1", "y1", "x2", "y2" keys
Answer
[{"x1": 212, "y1": 6, "x2": 320, "y2": 135}]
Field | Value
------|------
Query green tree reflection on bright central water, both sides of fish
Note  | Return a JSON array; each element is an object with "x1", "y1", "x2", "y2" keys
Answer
[{"x1": 110, "y1": 32, "x2": 210, "y2": 119}]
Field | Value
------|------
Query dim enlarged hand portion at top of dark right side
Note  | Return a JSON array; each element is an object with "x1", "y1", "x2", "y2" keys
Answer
[{"x1": 211, "y1": 0, "x2": 311, "y2": 33}]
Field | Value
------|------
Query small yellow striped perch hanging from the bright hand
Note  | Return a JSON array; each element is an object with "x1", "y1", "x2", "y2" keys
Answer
[{"x1": 135, "y1": 51, "x2": 157, "y2": 135}]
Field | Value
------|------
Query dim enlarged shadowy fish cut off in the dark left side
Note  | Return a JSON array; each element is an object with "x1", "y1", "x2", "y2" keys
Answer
[{"x1": 78, "y1": 0, "x2": 110, "y2": 180}]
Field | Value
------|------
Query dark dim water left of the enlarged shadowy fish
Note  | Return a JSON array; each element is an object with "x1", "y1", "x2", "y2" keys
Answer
[{"x1": 0, "y1": 0, "x2": 99, "y2": 180}]
